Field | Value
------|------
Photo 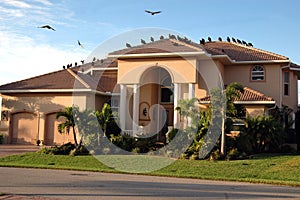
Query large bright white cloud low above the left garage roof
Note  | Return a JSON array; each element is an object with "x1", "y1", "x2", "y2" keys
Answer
[{"x1": 0, "y1": 32, "x2": 89, "y2": 85}]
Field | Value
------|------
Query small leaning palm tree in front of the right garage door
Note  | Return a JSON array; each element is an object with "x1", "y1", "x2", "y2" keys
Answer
[{"x1": 56, "y1": 106, "x2": 78, "y2": 148}]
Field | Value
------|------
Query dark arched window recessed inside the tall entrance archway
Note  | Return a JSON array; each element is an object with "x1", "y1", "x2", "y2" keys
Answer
[{"x1": 160, "y1": 76, "x2": 174, "y2": 103}]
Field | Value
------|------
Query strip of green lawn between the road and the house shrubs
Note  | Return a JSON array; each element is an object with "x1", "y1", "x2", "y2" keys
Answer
[{"x1": 0, "y1": 153, "x2": 300, "y2": 186}]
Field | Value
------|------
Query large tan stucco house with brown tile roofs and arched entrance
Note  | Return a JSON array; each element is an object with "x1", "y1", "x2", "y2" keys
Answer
[{"x1": 0, "y1": 35, "x2": 300, "y2": 145}]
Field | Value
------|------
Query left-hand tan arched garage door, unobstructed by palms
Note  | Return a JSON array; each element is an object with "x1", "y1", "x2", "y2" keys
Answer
[{"x1": 11, "y1": 112, "x2": 38, "y2": 144}]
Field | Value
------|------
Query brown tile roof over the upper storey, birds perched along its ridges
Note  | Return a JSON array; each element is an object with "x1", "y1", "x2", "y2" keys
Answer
[{"x1": 109, "y1": 39, "x2": 289, "y2": 62}]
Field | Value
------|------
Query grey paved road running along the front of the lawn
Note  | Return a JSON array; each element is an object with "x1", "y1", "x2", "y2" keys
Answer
[{"x1": 0, "y1": 168, "x2": 300, "y2": 200}]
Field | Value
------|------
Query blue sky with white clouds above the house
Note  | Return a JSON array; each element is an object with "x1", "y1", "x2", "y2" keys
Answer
[{"x1": 0, "y1": 0, "x2": 300, "y2": 89}]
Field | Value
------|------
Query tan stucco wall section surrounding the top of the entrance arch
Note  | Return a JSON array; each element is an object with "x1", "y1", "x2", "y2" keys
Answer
[{"x1": 118, "y1": 57, "x2": 196, "y2": 84}]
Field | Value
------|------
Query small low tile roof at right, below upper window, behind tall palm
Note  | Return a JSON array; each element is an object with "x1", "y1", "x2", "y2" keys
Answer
[{"x1": 200, "y1": 87, "x2": 274, "y2": 103}]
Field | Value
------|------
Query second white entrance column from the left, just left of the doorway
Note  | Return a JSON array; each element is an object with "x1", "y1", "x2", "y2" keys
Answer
[{"x1": 132, "y1": 84, "x2": 140, "y2": 136}]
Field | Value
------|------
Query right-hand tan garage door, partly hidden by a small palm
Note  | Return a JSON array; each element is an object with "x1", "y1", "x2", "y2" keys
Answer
[{"x1": 44, "y1": 113, "x2": 74, "y2": 145}]
